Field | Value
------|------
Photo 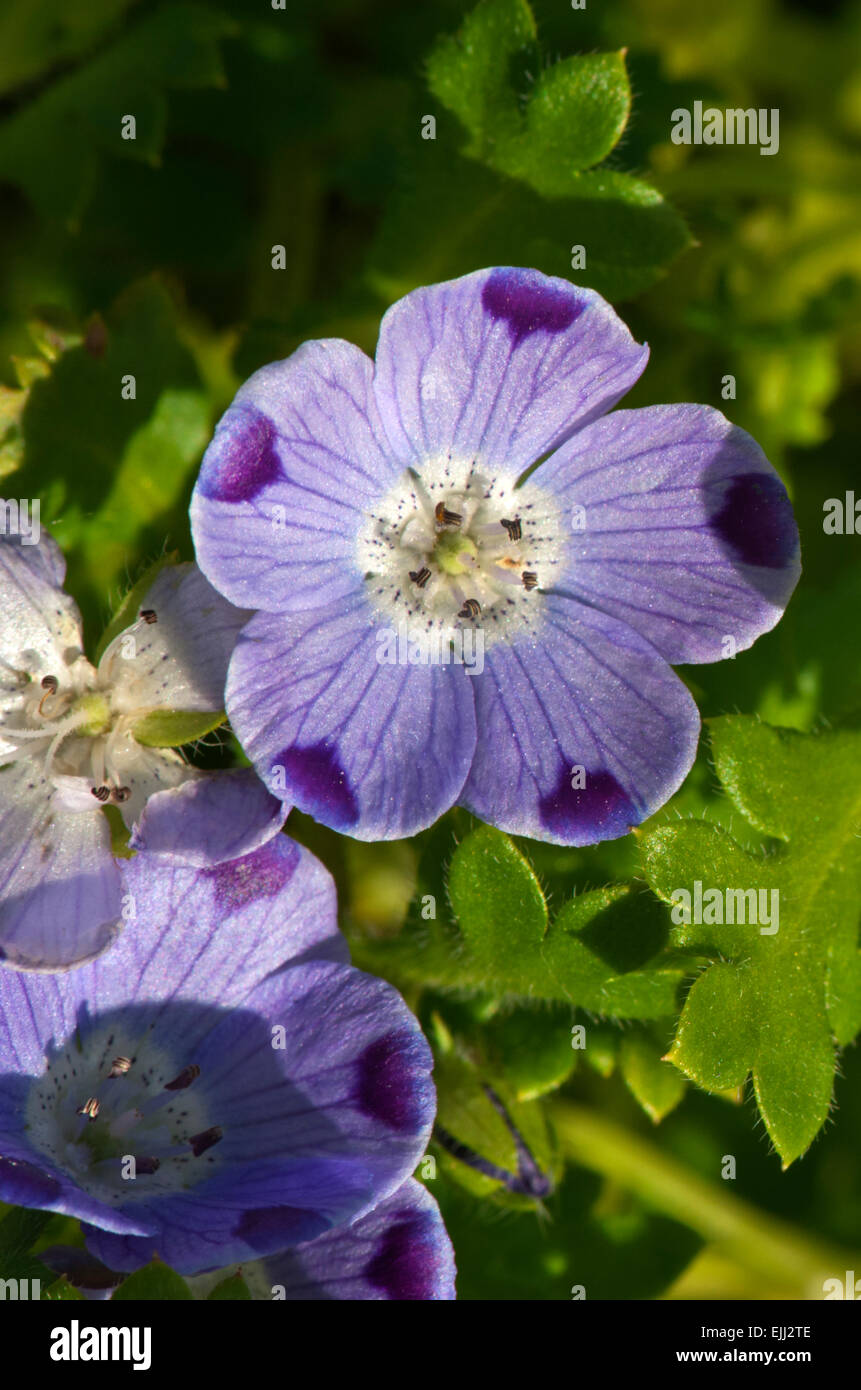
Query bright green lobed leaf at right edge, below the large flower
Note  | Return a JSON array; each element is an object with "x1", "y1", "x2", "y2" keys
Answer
[{"x1": 643, "y1": 716, "x2": 861, "y2": 1166}]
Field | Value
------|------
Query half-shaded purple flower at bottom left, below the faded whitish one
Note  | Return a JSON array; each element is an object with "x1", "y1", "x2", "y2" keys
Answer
[{"x1": 0, "y1": 792, "x2": 445, "y2": 1278}]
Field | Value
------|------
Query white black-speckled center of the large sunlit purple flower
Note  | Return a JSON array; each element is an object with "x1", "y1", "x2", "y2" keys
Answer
[{"x1": 357, "y1": 459, "x2": 565, "y2": 645}]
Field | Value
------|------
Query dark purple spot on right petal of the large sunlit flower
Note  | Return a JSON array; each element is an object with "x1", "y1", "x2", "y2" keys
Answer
[{"x1": 712, "y1": 473, "x2": 798, "y2": 570}]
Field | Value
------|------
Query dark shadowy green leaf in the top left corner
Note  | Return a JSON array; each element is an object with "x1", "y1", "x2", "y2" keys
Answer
[{"x1": 0, "y1": 4, "x2": 232, "y2": 225}]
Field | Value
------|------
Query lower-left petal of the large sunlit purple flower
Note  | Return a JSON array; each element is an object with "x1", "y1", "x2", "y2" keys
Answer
[{"x1": 227, "y1": 599, "x2": 476, "y2": 840}]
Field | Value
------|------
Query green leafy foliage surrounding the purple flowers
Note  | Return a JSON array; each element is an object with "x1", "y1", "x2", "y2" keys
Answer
[{"x1": 0, "y1": 0, "x2": 861, "y2": 1300}]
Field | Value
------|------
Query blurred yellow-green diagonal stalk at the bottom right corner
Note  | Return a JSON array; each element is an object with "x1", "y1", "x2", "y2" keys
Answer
[{"x1": 552, "y1": 1101, "x2": 861, "y2": 1298}]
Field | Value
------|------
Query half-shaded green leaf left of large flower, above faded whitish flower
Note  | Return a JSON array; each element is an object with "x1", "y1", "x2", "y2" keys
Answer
[{"x1": 15, "y1": 277, "x2": 211, "y2": 625}]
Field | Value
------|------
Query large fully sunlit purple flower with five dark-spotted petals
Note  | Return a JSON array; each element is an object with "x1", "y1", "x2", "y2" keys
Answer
[{"x1": 192, "y1": 268, "x2": 800, "y2": 845}]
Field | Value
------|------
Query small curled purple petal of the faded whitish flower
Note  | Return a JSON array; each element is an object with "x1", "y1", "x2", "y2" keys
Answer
[{"x1": 131, "y1": 767, "x2": 289, "y2": 867}]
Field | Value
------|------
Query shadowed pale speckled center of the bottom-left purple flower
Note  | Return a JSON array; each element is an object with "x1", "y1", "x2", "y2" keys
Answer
[{"x1": 26, "y1": 1024, "x2": 221, "y2": 1204}]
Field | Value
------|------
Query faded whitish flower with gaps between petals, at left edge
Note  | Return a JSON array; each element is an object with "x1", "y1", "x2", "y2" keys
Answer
[{"x1": 0, "y1": 534, "x2": 285, "y2": 970}]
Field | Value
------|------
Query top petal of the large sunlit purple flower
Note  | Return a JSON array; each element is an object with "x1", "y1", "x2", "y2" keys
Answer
[{"x1": 374, "y1": 267, "x2": 648, "y2": 475}]
